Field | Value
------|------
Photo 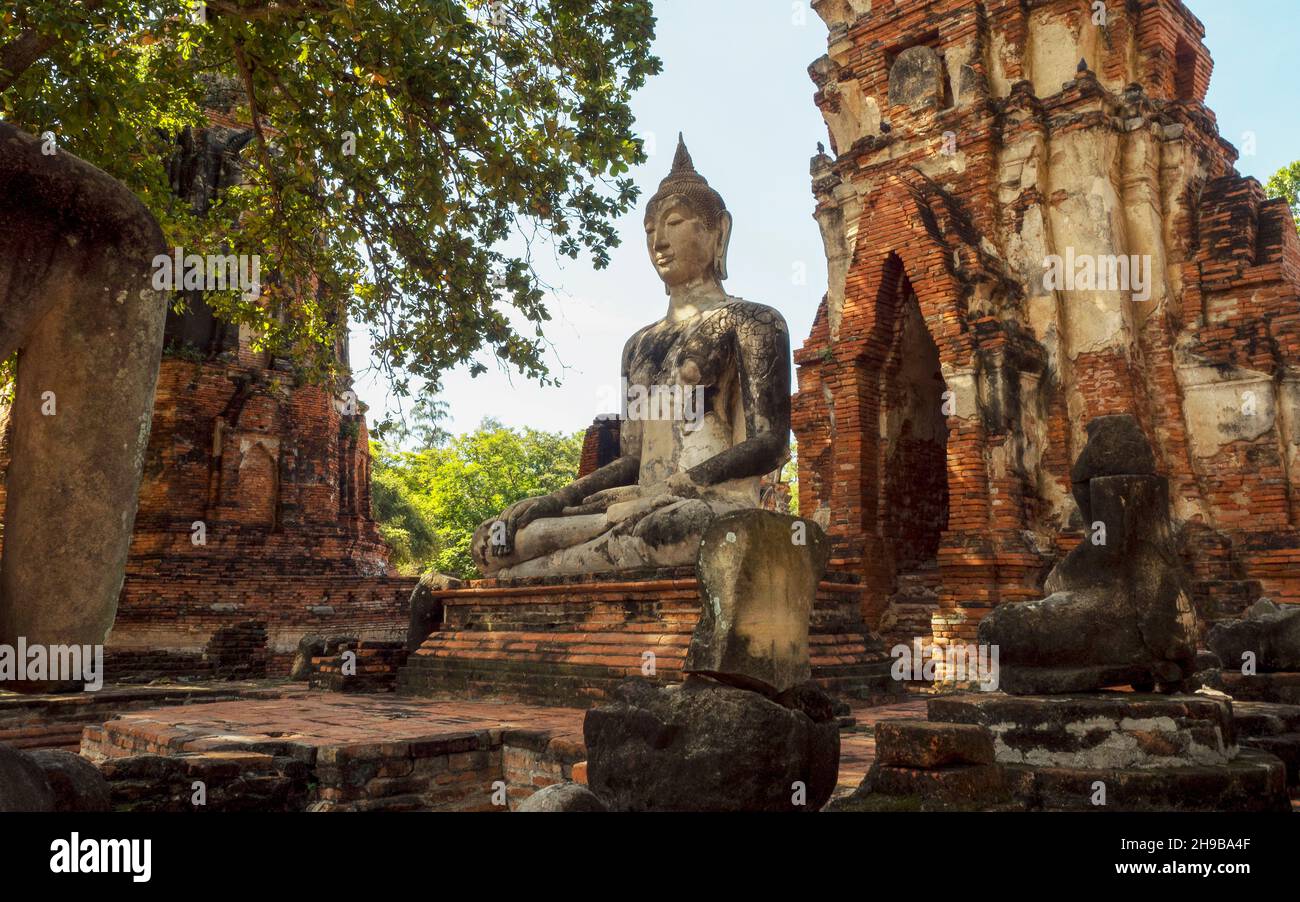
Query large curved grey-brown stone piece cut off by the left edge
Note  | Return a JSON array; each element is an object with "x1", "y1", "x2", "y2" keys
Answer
[{"x1": 0, "y1": 122, "x2": 166, "y2": 689}]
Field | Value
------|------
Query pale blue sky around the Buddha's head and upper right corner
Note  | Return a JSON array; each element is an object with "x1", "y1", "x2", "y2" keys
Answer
[{"x1": 352, "y1": 0, "x2": 1300, "y2": 433}]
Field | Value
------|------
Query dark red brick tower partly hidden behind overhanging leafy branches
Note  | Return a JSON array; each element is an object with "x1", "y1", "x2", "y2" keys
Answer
[{"x1": 94, "y1": 102, "x2": 395, "y2": 672}]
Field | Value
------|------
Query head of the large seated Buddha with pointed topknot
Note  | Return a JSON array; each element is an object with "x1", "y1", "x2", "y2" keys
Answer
[{"x1": 645, "y1": 134, "x2": 732, "y2": 292}]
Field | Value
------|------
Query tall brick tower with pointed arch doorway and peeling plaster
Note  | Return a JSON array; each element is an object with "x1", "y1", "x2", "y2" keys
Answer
[{"x1": 793, "y1": 0, "x2": 1300, "y2": 670}]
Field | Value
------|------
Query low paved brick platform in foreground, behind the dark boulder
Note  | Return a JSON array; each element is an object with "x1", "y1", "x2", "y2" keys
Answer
[{"x1": 81, "y1": 690, "x2": 924, "y2": 811}]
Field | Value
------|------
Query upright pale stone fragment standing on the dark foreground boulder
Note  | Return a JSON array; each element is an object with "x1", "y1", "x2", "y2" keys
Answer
[{"x1": 684, "y1": 509, "x2": 829, "y2": 695}]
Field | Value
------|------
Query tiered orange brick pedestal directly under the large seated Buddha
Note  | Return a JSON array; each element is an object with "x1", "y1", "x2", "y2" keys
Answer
[{"x1": 398, "y1": 568, "x2": 901, "y2": 706}]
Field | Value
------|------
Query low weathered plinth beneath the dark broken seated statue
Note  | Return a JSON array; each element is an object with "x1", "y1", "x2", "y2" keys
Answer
[{"x1": 833, "y1": 693, "x2": 1296, "y2": 812}]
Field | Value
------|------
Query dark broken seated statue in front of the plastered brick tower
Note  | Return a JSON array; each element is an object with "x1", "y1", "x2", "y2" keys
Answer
[{"x1": 979, "y1": 415, "x2": 1196, "y2": 694}]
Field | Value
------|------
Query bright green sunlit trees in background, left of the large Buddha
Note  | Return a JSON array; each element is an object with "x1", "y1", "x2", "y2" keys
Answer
[{"x1": 371, "y1": 420, "x2": 584, "y2": 578}]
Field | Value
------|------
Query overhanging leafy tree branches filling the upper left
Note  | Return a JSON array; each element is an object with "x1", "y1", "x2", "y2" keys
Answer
[{"x1": 0, "y1": 0, "x2": 659, "y2": 395}]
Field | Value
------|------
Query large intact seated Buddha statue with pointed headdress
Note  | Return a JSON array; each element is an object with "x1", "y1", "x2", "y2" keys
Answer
[{"x1": 473, "y1": 139, "x2": 790, "y2": 577}]
